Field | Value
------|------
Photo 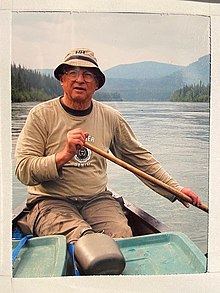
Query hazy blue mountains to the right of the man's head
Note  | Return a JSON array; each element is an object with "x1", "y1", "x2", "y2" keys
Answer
[{"x1": 99, "y1": 55, "x2": 210, "y2": 101}]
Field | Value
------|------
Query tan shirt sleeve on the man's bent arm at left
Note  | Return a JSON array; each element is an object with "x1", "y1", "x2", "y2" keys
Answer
[{"x1": 15, "y1": 111, "x2": 59, "y2": 186}]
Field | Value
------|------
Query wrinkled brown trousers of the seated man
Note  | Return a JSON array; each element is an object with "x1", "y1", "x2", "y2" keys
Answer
[{"x1": 18, "y1": 191, "x2": 132, "y2": 243}]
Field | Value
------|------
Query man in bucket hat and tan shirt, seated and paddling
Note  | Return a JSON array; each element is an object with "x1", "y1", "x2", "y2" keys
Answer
[{"x1": 16, "y1": 48, "x2": 201, "y2": 243}]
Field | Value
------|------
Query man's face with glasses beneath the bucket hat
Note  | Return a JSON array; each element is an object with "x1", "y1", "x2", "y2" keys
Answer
[{"x1": 60, "y1": 67, "x2": 98, "y2": 103}]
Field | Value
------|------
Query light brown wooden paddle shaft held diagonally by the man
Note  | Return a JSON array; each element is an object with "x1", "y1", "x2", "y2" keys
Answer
[{"x1": 85, "y1": 142, "x2": 209, "y2": 213}]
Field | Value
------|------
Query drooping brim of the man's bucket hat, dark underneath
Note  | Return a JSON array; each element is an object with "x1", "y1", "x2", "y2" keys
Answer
[{"x1": 54, "y1": 59, "x2": 105, "y2": 89}]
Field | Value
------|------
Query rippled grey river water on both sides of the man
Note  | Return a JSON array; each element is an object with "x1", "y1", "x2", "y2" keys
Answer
[{"x1": 12, "y1": 102, "x2": 209, "y2": 253}]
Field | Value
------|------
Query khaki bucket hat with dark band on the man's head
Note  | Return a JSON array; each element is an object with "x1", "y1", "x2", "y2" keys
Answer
[{"x1": 54, "y1": 48, "x2": 105, "y2": 89}]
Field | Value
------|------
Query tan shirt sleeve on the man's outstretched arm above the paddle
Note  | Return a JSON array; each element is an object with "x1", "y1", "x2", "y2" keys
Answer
[{"x1": 110, "y1": 116, "x2": 183, "y2": 202}]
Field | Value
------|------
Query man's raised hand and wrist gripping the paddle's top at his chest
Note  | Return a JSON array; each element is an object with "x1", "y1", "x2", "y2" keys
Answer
[{"x1": 56, "y1": 128, "x2": 89, "y2": 170}]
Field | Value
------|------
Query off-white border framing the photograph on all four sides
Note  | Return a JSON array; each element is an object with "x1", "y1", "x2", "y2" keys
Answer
[{"x1": 0, "y1": 0, "x2": 220, "y2": 293}]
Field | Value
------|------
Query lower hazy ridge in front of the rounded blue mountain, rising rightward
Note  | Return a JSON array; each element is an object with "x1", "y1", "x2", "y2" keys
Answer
[{"x1": 100, "y1": 55, "x2": 210, "y2": 101}]
